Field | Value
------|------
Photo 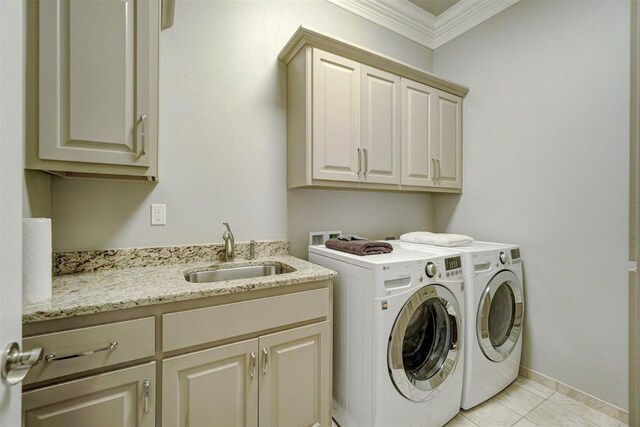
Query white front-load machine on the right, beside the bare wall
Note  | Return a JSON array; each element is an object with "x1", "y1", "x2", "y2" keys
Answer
[{"x1": 400, "y1": 242, "x2": 524, "y2": 409}]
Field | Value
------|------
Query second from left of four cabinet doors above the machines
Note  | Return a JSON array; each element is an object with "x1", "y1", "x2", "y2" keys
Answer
[{"x1": 362, "y1": 65, "x2": 400, "y2": 184}]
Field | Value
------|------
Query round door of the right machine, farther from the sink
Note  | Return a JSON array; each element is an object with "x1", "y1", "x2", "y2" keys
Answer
[{"x1": 477, "y1": 270, "x2": 524, "y2": 362}]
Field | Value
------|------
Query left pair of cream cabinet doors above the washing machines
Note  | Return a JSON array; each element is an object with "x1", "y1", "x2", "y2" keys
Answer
[{"x1": 312, "y1": 49, "x2": 400, "y2": 184}]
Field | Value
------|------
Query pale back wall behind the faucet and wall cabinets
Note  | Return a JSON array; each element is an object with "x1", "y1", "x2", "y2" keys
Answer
[{"x1": 51, "y1": 0, "x2": 432, "y2": 256}]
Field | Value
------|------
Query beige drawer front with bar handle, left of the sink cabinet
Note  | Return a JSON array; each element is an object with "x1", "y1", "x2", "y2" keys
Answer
[{"x1": 22, "y1": 317, "x2": 155, "y2": 384}]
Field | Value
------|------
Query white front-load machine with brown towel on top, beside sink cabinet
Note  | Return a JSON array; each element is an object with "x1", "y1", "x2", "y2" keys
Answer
[{"x1": 309, "y1": 245, "x2": 464, "y2": 427}]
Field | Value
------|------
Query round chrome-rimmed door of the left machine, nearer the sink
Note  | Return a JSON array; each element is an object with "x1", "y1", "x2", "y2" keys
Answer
[{"x1": 388, "y1": 285, "x2": 461, "y2": 401}]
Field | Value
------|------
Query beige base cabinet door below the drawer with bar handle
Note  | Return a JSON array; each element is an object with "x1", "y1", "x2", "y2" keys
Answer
[{"x1": 22, "y1": 362, "x2": 156, "y2": 427}]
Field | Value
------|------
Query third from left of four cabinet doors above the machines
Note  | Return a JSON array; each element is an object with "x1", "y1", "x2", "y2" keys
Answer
[{"x1": 401, "y1": 79, "x2": 439, "y2": 187}]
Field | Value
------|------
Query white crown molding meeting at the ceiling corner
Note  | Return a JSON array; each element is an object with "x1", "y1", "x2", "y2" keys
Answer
[{"x1": 327, "y1": 0, "x2": 519, "y2": 49}]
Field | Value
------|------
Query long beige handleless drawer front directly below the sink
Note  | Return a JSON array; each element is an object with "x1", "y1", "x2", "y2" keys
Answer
[{"x1": 162, "y1": 288, "x2": 329, "y2": 351}]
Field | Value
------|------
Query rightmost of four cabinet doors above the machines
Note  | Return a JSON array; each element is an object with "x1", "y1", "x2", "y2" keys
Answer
[{"x1": 434, "y1": 91, "x2": 462, "y2": 188}]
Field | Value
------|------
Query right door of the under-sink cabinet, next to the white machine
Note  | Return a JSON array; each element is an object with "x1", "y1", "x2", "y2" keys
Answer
[{"x1": 259, "y1": 322, "x2": 331, "y2": 427}]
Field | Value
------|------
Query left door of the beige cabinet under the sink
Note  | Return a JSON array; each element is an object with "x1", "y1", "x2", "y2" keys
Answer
[{"x1": 162, "y1": 338, "x2": 258, "y2": 427}]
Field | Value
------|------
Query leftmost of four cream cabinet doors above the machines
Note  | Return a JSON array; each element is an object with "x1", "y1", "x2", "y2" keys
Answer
[{"x1": 313, "y1": 49, "x2": 362, "y2": 181}]
